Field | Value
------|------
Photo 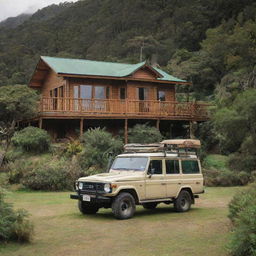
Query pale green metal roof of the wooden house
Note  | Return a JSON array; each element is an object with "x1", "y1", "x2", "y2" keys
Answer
[{"x1": 41, "y1": 56, "x2": 186, "y2": 82}]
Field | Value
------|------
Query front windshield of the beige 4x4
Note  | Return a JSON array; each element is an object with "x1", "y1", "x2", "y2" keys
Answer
[{"x1": 111, "y1": 157, "x2": 148, "y2": 171}]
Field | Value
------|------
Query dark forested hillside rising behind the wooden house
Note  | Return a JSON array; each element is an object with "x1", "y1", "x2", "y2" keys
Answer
[{"x1": 0, "y1": 0, "x2": 255, "y2": 98}]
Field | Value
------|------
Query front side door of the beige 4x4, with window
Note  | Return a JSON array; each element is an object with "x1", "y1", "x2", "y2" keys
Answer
[{"x1": 145, "y1": 159, "x2": 166, "y2": 199}]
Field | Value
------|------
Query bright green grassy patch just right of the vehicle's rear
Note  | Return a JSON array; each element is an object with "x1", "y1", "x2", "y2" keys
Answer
[{"x1": 203, "y1": 154, "x2": 228, "y2": 171}]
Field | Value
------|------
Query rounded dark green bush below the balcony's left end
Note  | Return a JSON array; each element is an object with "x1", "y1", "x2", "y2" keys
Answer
[{"x1": 12, "y1": 126, "x2": 51, "y2": 153}]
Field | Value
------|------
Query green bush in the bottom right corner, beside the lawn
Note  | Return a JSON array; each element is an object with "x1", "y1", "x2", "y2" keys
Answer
[{"x1": 229, "y1": 184, "x2": 256, "y2": 256}]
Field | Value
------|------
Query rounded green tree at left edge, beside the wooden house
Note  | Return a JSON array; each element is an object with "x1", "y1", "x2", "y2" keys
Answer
[{"x1": 0, "y1": 85, "x2": 39, "y2": 166}]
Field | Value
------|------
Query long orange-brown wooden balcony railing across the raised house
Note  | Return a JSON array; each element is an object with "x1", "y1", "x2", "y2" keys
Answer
[{"x1": 40, "y1": 97, "x2": 209, "y2": 121}]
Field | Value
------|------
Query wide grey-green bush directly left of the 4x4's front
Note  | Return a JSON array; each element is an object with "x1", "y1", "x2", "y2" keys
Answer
[{"x1": 21, "y1": 158, "x2": 83, "y2": 191}]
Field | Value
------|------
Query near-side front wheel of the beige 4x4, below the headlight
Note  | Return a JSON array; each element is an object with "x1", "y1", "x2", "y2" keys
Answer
[{"x1": 111, "y1": 192, "x2": 136, "y2": 220}]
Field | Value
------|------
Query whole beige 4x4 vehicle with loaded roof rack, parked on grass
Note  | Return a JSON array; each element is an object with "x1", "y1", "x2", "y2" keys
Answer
[{"x1": 70, "y1": 140, "x2": 204, "y2": 219}]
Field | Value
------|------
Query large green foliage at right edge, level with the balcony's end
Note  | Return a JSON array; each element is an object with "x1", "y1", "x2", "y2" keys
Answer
[{"x1": 213, "y1": 89, "x2": 256, "y2": 173}]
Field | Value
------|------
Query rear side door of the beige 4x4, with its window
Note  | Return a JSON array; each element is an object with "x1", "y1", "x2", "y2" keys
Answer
[{"x1": 165, "y1": 159, "x2": 181, "y2": 197}]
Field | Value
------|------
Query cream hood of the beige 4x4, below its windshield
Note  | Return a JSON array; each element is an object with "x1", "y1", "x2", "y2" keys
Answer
[{"x1": 79, "y1": 171, "x2": 144, "y2": 182}]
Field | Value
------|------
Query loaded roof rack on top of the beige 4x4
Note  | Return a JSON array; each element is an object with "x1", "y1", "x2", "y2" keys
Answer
[{"x1": 124, "y1": 139, "x2": 201, "y2": 156}]
